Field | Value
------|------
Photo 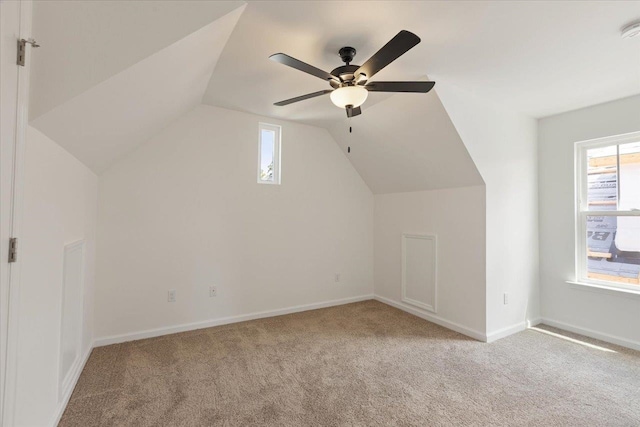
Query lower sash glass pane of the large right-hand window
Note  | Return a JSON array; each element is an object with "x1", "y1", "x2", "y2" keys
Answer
[{"x1": 587, "y1": 216, "x2": 640, "y2": 285}]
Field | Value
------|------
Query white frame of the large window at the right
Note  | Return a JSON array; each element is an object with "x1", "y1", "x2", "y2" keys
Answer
[{"x1": 572, "y1": 132, "x2": 640, "y2": 292}]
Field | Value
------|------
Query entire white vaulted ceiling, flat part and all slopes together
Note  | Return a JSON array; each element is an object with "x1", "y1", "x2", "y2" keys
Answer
[{"x1": 30, "y1": 0, "x2": 640, "y2": 193}]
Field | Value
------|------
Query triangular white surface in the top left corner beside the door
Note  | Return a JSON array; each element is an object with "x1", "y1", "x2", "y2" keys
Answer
[{"x1": 29, "y1": 0, "x2": 244, "y2": 120}]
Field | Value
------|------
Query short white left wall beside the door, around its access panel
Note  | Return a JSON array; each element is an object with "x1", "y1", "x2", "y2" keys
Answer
[{"x1": 15, "y1": 127, "x2": 98, "y2": 426}]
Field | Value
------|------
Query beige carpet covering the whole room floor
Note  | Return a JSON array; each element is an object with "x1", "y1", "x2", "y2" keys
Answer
[{"x1": 60, "y1": 301, "x2": 640, "y2": 427}]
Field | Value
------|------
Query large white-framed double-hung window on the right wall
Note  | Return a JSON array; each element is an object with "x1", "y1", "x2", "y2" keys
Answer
[{"x1": 576, "y1": 132, "x2": 640, "y2": 290}]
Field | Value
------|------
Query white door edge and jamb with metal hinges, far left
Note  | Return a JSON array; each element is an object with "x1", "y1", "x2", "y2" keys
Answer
[{"x1": 0, "y1": 0, "x2": 32, "y2": 426}]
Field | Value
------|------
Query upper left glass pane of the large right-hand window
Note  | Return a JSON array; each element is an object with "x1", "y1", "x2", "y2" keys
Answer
[{"x1": 587, "y1": 145, "x2": 618, "y2": 211}]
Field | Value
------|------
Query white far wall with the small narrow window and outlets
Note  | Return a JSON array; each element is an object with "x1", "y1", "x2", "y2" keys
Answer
[{"x1": 96, "y1": 106, "x2": 373, "y2": 338}]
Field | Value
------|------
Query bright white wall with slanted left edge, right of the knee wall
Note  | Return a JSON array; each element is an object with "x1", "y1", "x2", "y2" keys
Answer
[{"x1": 436, "y1": 82, "x2": 540, "y2": 340}]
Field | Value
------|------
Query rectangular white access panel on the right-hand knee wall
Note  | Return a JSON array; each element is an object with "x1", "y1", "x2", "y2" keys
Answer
[{"x1": 402, "y1": 233, "x2": 437, "y2": 313}]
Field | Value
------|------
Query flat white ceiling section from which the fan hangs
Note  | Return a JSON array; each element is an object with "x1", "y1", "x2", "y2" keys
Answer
[{"x1": 204, "y1": 1, "x2": 640, "y2": 122}]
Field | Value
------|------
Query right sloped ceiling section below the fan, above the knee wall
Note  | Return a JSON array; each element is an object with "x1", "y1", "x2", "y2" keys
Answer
[{"x1": 329, "y1": 91, "x2": 483, "y2": 194}]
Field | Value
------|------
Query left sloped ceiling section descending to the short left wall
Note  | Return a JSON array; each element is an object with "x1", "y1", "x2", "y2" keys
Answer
[{"x1": 31, "y1": 6, "x2": 244, "y2": 173}]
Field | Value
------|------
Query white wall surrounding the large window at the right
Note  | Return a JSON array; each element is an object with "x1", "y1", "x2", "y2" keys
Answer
[{"x1": 538, "y1": 96, "x2": 640, "y2": 348}]
